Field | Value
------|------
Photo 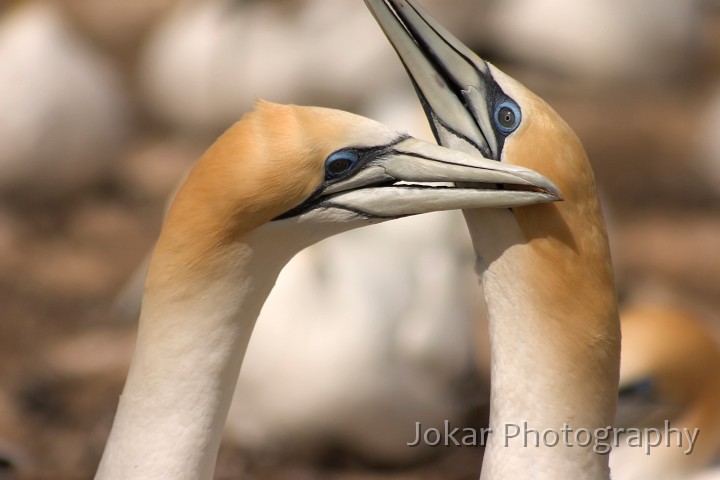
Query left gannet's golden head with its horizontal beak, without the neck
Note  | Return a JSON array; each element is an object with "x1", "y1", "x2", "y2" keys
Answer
[{"x1": 148, "y1": 102, "x2": 558, "y2": 290}]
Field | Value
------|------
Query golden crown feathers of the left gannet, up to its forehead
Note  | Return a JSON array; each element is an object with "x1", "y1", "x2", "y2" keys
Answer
[{"x1": 163, "y1": 101, "x2": 393, "y2": 242}]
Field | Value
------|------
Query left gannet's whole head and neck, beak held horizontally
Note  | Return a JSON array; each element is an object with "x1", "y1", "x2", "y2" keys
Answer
[{"x1": 96, "y1": 99, "x2": 558, "y2": 479}]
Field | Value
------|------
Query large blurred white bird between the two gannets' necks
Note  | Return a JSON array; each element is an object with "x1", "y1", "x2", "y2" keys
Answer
[{"x1": 225, "y1": 209, "x2": 487, "y2": 465}]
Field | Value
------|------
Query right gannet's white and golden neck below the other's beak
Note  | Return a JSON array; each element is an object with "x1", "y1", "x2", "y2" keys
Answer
[{"x1": 465, "y1": 205, "x2": 620, "y2": 480}]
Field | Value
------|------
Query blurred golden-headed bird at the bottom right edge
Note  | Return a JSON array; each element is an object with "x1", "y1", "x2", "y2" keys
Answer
[{"x1": 610, "y1": 306, "x2": 720, "y2": 480}]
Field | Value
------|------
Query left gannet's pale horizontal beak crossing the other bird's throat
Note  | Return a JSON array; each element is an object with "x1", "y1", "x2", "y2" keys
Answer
[{"x1": 314, "y1": 137, "x2": 560, "y2": 218}]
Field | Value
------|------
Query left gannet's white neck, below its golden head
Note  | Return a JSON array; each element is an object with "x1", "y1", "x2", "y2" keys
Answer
[{"x1": 96, "y1": 234, "x2": 292, "y2": 479}]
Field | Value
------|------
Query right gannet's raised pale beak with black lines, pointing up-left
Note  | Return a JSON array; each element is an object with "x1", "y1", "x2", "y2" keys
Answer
[{"x1": 365, "y1": 0, "x2": 504, "y2": 160}]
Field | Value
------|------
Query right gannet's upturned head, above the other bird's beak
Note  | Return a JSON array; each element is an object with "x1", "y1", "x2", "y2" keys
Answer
[{"x1": 366, "y1": 0, "x2": 594, "y2": 206}]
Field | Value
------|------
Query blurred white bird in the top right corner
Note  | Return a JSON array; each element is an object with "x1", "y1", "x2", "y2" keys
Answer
[{"x1": 486, "y1": 0, "x2": 701, "y2": 82}]
